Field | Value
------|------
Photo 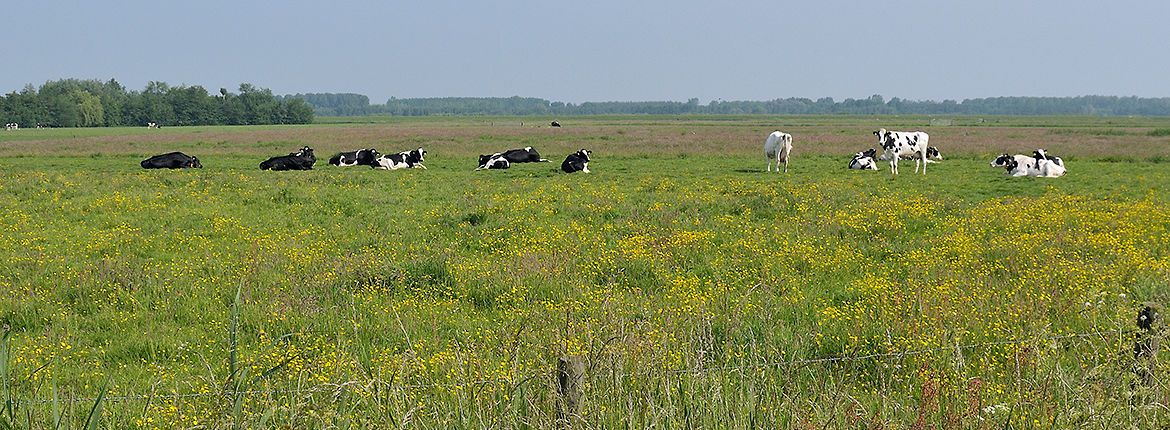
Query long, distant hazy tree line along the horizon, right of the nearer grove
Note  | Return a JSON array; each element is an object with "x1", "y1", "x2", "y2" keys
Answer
[{"x1": 294, "y1": 93, "x2": 1170, "y2": 116}]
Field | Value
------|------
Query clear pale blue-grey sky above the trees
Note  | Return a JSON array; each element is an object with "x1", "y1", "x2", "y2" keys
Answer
[{"x1": 0, "y1": 0, "x2": 1170, "y2": 103}]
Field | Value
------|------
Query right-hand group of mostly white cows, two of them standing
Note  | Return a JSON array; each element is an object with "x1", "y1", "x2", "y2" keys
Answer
[{"x1": 764, "y1": 129, "x2": 1066, "y2": 178}]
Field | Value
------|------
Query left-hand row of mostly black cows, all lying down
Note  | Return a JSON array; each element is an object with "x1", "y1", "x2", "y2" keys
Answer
[{"x1": 142, "y1": 146, "x2": 591, "y2": 173}]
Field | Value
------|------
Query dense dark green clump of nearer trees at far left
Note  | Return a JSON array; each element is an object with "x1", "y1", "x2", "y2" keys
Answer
[{"x1": 0, "y1": 79, "x2": 314, "y2": 127}]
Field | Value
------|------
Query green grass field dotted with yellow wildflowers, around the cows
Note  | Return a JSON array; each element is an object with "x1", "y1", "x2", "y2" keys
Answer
[{"x1": 0, "y1": 116, "x2": 1170, "y2": 429}]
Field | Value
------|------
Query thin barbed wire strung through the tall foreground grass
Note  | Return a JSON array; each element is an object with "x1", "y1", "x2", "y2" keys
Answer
[{"x1": 8, "y1": 327, "x2": 1140, "y2": 407}]
